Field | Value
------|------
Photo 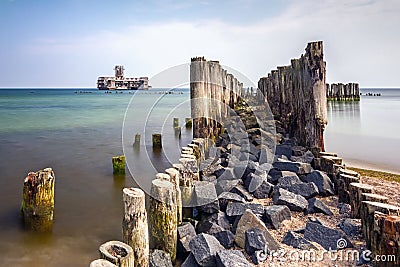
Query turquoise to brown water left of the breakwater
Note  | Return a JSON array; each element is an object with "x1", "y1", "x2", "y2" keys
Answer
[{"x1": 0, "y1": 89, "x2": 191, "y2": 266}]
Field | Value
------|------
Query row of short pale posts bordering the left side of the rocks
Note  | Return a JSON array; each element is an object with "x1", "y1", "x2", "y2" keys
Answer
[{"x1": 90, "y1": 138, "x2": 209, "y2": 267}]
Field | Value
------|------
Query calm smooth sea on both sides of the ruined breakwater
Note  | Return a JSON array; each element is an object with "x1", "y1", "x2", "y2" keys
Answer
[{"x1": 0, "y1": 88, "x2": 400, "y2": 267}]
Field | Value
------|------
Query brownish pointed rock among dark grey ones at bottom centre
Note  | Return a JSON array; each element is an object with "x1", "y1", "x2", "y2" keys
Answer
[{"x1": 235, "y1": 209, "x2": 279, "y2": 250}]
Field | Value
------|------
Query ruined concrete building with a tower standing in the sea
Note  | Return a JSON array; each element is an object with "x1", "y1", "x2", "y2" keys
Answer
[{"x1": 97, "y1": 65, "x2": 150, "y2": 90}]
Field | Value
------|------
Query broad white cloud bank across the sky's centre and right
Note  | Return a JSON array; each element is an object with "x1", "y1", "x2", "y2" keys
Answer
[{"x1": 20, "y1": 0, "x2": 400, "y2": 87}]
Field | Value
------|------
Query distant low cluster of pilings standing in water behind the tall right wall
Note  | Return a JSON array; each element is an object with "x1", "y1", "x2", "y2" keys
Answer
[{"x1": 326, "y1": 83, "x2": 360, "y2": 101}]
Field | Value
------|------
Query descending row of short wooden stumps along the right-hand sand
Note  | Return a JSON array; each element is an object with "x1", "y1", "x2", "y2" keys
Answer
[{"x1": 319, "y1": 152, "x2": 400, "y2": 266}]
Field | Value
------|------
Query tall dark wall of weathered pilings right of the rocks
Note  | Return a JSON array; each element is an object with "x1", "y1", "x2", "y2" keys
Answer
[{"x1": 258, "y1": 41, "x2": 327, "y2": 155}]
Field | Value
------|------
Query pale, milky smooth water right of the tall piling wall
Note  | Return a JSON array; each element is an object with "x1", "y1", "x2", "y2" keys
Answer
[{"x1": 325, "y1": 88, "x2": 400, "y2": 173}]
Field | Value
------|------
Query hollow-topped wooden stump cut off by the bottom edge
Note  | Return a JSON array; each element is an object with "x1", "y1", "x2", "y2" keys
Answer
[{"x1": 99, "y1": 241, "x2": 135, "y2": 267}]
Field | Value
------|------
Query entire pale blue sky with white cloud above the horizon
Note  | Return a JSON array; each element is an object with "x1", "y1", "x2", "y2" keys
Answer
[{"x1": 0, "y1": 0, "x2": 400, "y2": 88}]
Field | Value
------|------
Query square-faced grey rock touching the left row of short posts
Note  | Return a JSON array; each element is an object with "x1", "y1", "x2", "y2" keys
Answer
[{"x1": 194, "y1": 181, "x2": 219, "y2": 213}]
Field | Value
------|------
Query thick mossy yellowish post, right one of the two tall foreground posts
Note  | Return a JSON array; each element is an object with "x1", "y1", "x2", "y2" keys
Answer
[{"x1": 149, "y1": 179, "x2": 178, "y2": 262}]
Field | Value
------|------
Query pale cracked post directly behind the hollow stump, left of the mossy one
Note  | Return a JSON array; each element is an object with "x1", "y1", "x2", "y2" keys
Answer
[{"x1": 122, "y1": 188, "x2": 150, "y2": 267}]
